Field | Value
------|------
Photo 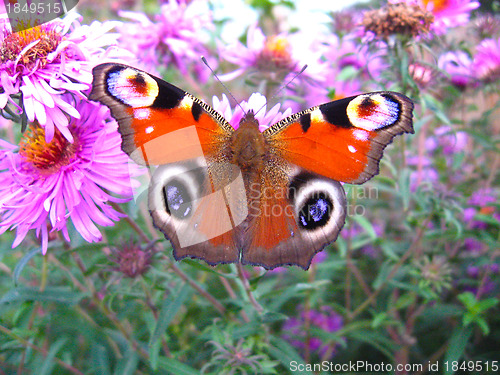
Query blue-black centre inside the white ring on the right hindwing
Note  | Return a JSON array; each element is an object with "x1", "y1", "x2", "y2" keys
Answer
[{"x1": 298, "y1": 192, "x2": 333, "y2": 230}]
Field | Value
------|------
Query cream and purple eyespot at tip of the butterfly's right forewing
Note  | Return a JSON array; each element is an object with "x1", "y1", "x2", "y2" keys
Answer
[{"x1": 347, "y1": 94, "x2": 401, "y2": 131}]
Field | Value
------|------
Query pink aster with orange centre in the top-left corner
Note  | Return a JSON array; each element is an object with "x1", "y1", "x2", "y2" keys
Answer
[{"x1": 0, "y1": 12, "x2": 126, "y2": 142}]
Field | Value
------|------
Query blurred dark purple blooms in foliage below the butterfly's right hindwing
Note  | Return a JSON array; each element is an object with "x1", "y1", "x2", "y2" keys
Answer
[{"x1": 282, "y1": 306, "x2": 343, "y2": 356}]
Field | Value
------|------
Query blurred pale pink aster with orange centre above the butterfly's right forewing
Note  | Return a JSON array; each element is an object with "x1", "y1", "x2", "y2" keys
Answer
[{"x1": 219, "y1": 25, "x2": 328, "y2": 90}]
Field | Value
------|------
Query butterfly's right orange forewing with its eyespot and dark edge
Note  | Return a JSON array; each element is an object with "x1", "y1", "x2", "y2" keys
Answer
[{"x1": 264, "y1": 91, "x2": 413, "y2": 184}]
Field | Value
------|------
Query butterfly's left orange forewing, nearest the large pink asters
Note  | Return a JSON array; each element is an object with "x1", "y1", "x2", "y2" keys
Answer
[{"x1": 89, "y1": 63, "x2": 234, "y2": 165}]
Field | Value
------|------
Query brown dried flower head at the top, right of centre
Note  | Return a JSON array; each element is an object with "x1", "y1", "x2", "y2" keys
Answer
[{"x1": 361, "y1": 3, "x2": 434, "y2": 38}]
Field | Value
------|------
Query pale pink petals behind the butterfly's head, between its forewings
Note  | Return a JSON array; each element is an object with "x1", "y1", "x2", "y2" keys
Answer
[{"x1": 212, "y1": 93, "x2": 292, "y2": 132}]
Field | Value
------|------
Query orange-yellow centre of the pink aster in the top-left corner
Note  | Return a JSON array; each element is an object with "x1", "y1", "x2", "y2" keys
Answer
[{"x1": 0, "y1": 24, "x2": 62, "y2": 69}]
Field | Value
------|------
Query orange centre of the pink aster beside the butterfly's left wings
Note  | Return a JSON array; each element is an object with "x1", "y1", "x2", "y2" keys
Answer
[{"x1": 19, "y1": 122, "x2": 78, "y2": 175}]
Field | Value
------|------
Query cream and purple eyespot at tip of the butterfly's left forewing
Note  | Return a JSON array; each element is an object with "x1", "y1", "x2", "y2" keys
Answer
[{"x1": 106, "y1": 68, "x2": 159, "y2": 108}]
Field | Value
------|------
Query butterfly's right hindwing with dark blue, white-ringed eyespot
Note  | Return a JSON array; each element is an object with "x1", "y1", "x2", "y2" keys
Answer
[{"x1": 241, "y1": 165, "x2": 346, "y2": 269}]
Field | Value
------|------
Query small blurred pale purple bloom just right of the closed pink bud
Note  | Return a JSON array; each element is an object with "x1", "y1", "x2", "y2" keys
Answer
[{"x1": 438, "y1": 51, "x2": 474, "y2": 89}]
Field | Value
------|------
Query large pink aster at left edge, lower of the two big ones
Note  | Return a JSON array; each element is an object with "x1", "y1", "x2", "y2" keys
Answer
[{"x1": 0, "y1": 101, "x2": 137, "y2": 253}]
